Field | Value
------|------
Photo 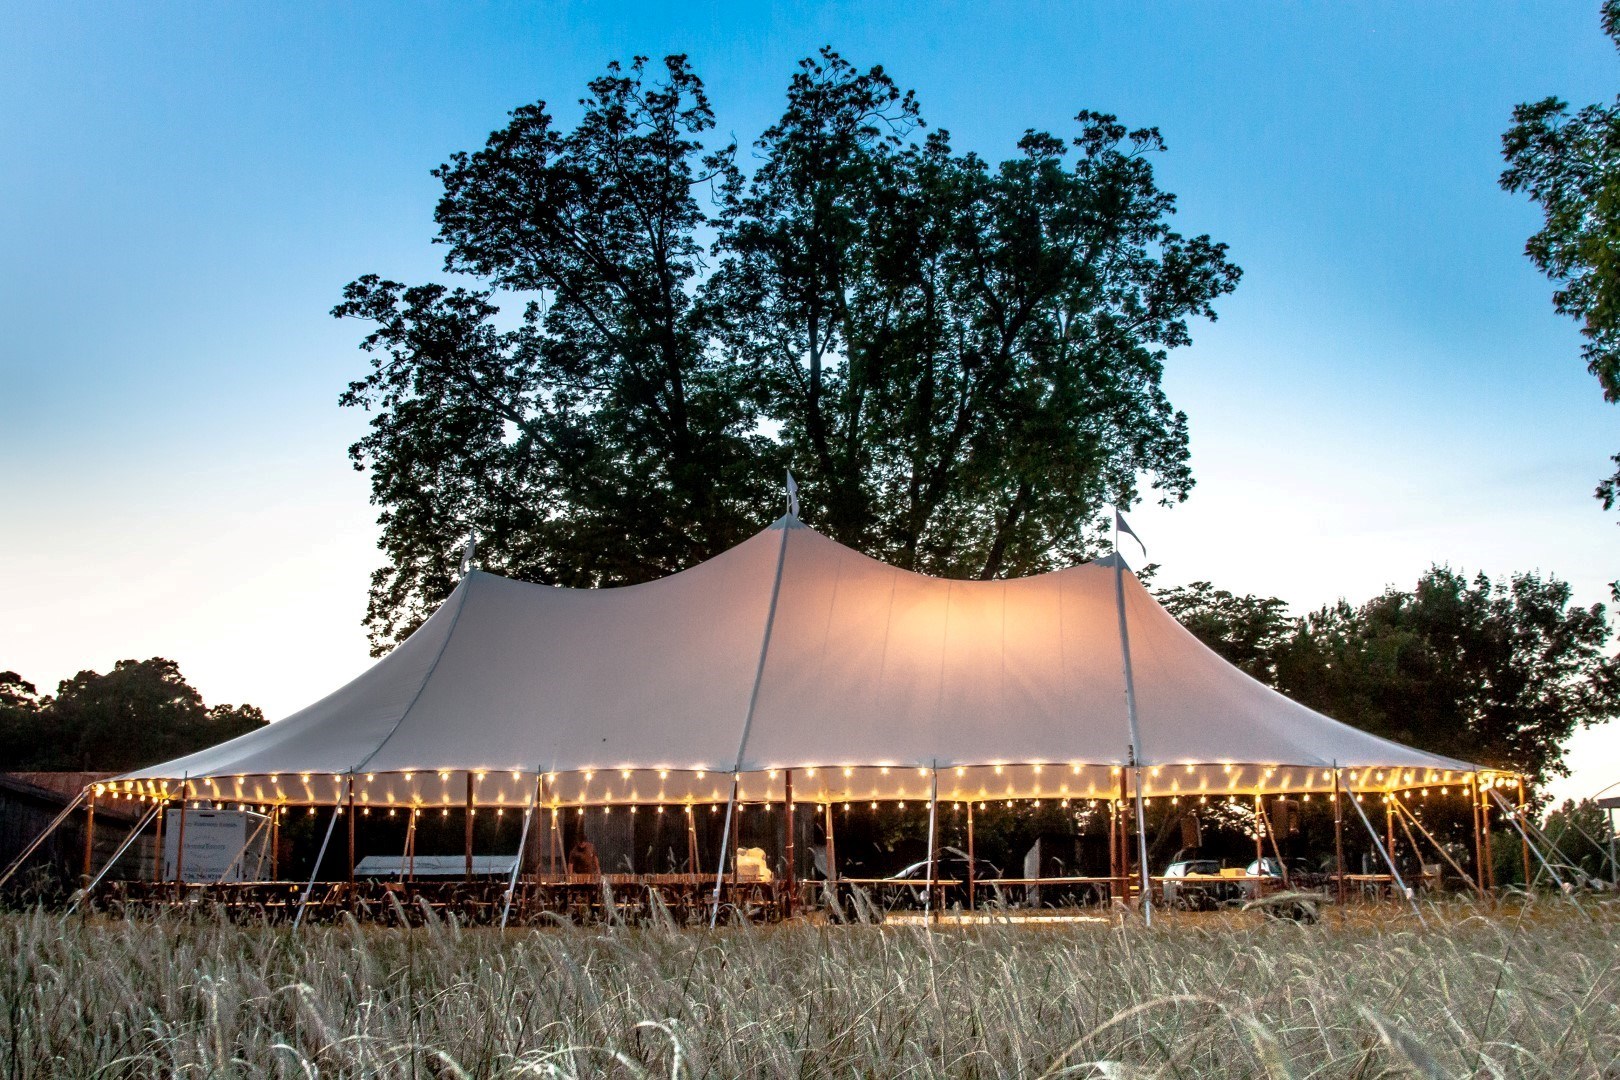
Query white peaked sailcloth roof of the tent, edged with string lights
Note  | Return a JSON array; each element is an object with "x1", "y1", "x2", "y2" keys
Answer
[{"x1": 112, "y1": 515, "x2": 1476, "y2": 808}]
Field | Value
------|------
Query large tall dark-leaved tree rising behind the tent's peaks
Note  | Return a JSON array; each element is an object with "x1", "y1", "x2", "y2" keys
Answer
[{"x1": 334, "y1": 50, "x2": 1239, "y2": 653}]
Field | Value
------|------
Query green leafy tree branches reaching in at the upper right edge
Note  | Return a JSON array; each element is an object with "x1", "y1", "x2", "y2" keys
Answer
[{"x1": 1502, "y1": 0, "x2": 1620, "y2": 557}]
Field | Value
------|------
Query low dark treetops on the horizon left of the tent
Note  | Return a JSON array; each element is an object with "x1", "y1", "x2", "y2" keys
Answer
[{"x1": 0, "y1": 656, "x2": 266, "y2": 772}]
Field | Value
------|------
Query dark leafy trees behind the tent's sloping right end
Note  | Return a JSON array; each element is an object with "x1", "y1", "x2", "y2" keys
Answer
[{"x1": 1160, "y1": 567, "x2": 1620, "y2": 782}]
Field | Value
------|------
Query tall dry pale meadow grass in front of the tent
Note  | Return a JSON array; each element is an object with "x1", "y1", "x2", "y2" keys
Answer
[{"x1": 0, "y1": 902, "x2": 1620, "y2": 1080}]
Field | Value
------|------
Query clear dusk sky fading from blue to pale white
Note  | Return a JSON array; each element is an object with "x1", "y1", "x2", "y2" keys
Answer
[{"x1": 0, "y1": 2, "x2": 1620, "y2": 795}]
